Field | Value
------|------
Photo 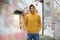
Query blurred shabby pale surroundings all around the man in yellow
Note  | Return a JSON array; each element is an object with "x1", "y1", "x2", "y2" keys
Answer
[{"x1": 0, "y1": 0, "x2": 60, "y2": 40}]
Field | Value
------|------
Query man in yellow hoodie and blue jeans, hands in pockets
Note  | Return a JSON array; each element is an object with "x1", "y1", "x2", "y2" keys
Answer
[{"x1": 24, "y1": 4, "x2": 42, "y2": 40}]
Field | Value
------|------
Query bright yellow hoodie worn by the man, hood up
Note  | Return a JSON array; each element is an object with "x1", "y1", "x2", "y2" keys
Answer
[{"x1": 24, "y1": 5, "x2": 42, "y2": 34}]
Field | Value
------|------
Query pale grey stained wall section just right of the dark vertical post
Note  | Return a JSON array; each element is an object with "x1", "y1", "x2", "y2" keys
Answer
[{"x1": 44, "y1": 0, "x2": 54, "y2": 37}]
